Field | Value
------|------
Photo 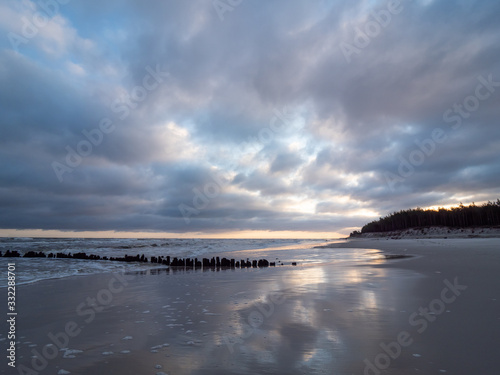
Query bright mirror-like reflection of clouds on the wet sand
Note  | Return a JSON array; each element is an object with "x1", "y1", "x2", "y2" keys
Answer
[{"x1": 186, "y1": 254, "x2": 415, "y2": 374}]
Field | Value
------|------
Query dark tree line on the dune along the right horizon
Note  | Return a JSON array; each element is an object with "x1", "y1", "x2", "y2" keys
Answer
[{"x1": 352, "y1": 199, "x2": 500, "y2": 236}]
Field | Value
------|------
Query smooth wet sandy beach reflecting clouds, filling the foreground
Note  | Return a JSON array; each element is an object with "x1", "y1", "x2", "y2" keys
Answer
[{"x1": 0, "y1": 238, "x2": 500, "y2": 375}]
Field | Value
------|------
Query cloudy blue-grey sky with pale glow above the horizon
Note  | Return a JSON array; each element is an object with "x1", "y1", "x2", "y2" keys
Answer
[{"x1": 0, "y1": 0, "x2": 500, "y2": 238}]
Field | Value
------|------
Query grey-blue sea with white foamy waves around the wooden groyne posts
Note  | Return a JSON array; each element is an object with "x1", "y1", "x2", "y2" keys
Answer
[{"x1": 0, "y1": 237, "x2": 380, "y2": 287}]
